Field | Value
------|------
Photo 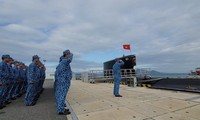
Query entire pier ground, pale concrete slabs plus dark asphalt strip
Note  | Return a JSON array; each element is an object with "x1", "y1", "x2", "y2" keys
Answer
[{"x1": 0, "y1": 80, "x2": 200, "y2": 120}]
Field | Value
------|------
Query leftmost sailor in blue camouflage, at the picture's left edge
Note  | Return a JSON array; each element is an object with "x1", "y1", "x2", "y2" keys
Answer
[{"x1": 0, "y1": 55, "x2": 10, "y2": 109}]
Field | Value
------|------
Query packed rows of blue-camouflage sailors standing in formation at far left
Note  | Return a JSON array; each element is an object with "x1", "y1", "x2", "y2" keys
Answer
[{"x1": 0, "y1": 54, "x2": 45, "y2": 109}]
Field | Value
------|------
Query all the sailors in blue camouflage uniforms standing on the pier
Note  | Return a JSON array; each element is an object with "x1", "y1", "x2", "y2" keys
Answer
[{"x1": 0, "y1": 50, "x2": 124, "y2": 115}]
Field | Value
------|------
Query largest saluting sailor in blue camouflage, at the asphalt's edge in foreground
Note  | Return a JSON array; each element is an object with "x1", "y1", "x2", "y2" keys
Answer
[{"x1": 55, "y1": 50, "x2": 73, "y2": 115}]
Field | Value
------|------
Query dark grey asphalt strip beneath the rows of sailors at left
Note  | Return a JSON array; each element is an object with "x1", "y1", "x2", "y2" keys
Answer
[{"x1": 0, "y1": 80, "x2": 67, "y2": 120}]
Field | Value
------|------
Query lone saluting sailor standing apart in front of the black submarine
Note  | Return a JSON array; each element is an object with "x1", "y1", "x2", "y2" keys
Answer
[{"x1": 113, "y1": 59, "x2": 124, "y2": 97}]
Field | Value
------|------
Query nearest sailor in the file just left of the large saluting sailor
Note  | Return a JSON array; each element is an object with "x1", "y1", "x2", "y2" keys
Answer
[{"x1": 25, "y1": 55, "x2": 40, "y2": 106}]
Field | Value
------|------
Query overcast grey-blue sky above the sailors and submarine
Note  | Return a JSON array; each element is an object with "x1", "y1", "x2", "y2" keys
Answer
[{"x1": 0, "y1": 0, "x2": 200, "y2": 72}]
